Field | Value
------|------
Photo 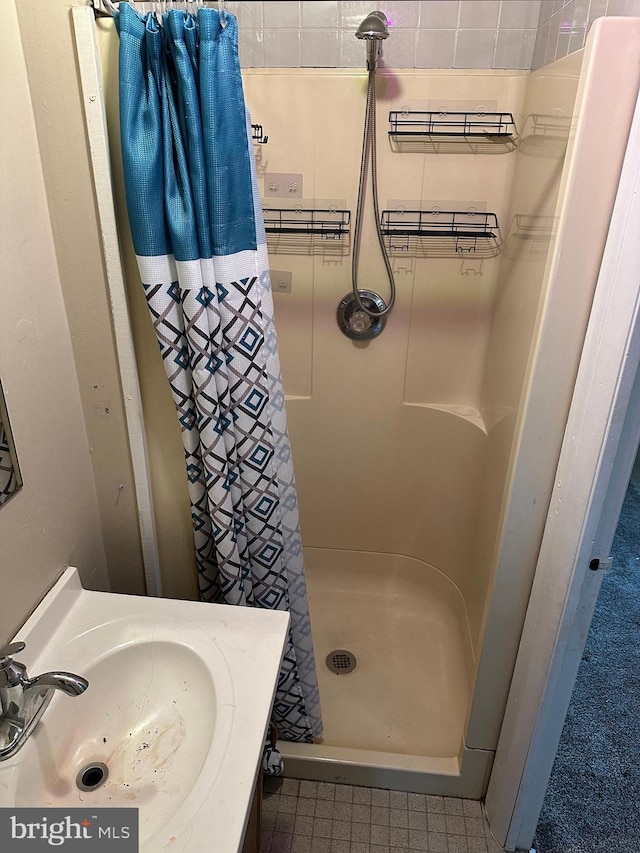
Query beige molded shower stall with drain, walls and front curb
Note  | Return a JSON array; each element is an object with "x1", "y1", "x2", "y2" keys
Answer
[{"x1": 87, "y1": 13, "x2": 640, "y2": 797}]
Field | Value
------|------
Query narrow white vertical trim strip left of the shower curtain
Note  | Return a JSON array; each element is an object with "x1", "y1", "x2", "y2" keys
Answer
[{"x1": 72, "y1": 6, "x2": 162, "y2": 596}]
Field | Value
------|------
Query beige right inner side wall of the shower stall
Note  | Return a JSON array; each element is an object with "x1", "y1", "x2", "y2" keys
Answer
[{"x1": 469, "y1": 53, "x2": 582, "y2": 644}]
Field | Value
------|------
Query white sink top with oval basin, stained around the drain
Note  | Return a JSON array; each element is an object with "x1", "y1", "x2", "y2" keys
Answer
[{"x1": 0, "y1": 569, "x2": 289, "y2": 853}]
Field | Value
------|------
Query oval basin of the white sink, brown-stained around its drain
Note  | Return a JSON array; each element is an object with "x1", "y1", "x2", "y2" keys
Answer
[{"x1": 15, "y1": 638, "x2": 220, "y2": 812}]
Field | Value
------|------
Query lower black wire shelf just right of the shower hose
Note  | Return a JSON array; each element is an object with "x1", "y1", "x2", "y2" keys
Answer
[{"x1": 380, "y1": 210, "x2": 502, "y2": 258}]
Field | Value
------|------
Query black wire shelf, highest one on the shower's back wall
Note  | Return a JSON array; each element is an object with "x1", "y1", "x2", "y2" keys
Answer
[{"x1": 389, "y1": 110, "x2": 517, "y2": 154}]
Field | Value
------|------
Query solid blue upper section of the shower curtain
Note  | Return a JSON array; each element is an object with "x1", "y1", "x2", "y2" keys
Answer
[{"x1": 117, "y1": 3, "x2": 256, "y2": 261}]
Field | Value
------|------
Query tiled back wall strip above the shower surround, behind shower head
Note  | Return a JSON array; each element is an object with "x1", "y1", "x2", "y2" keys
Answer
[{"x1": 227, "y1": 0, "x2": 541, "y2": 69}]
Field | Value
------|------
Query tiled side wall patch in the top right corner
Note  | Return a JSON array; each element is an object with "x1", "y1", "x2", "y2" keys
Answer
[{"x1": 531, "y1": 0, "x2": 640, "y2": 70}]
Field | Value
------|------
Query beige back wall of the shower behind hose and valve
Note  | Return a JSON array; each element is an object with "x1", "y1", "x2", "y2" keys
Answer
[{"x1": 244, "y1": 70, "x2": 527, "y2": 638}]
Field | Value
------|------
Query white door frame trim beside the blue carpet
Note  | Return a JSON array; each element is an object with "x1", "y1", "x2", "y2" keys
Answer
[{"x1": 486, "y1": 85, "x2": 640, "y2": 850}]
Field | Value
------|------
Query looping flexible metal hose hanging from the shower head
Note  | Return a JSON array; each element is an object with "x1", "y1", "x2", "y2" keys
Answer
[{"x1": 351, "y1": 42, "x2": 396, "y2": 317}]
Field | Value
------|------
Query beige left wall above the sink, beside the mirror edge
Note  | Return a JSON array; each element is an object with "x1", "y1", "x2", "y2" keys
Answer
[{"x1": 0, "y1": 0, "x2": 108, "y2": 643}]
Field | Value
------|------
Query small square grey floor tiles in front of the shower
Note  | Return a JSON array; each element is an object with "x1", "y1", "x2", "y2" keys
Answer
[{"x1": 260, "y1": 777, "x2": 501, "y2": 853}]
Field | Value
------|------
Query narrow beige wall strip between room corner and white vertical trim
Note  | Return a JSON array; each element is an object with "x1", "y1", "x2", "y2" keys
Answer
[{"x1": 16, "y1": 0, "x2": 145, "y2": 593}]
